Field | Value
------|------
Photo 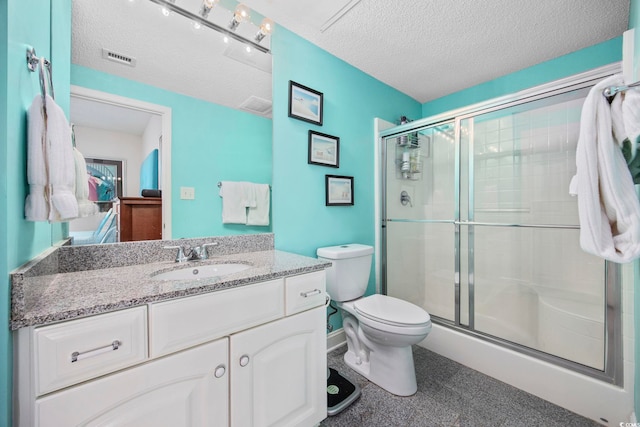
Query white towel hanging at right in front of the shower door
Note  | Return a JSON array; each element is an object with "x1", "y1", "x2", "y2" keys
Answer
[{"x1": 569, "y1": 75, "x2": 640, "y2": 262}]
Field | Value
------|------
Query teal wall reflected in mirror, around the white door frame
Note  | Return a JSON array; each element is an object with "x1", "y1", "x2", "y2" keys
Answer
[{"x1": 71, "y1": 65, "x2": 272, "y2": 239}]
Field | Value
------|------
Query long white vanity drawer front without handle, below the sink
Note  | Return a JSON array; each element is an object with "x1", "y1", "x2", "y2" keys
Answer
[{"x1": 149, "y1": 279, "x2": 284, "y2": 357}]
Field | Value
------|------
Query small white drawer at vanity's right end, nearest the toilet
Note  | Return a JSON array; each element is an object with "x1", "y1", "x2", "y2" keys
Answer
[{"x1": 285, "y1": 270, "x2": 326, "y2": 316}]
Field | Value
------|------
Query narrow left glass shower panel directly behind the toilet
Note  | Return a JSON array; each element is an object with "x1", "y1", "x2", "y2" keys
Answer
[{"x1": 384, "y1": 122, "x2": 457, "y2": 321}]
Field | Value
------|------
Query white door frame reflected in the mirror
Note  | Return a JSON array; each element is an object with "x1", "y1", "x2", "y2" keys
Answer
[{"x1": 71, "y1": 85, "x2": 171, "y2": 240}]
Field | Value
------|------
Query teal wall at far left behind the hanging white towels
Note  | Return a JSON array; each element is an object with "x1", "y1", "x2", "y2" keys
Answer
[{"x1": 0, "y1": 0, "x2": 71, "y2": 426}]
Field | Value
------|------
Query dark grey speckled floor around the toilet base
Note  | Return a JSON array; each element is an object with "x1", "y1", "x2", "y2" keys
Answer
[{"x1": 320, "y1": 346, "x2": 600, "y2": 427}]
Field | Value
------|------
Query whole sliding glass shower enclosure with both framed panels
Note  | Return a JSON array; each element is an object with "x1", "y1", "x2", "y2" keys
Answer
[{"x1": 381, "y1": 72, "x2": 620, "y2": 383}]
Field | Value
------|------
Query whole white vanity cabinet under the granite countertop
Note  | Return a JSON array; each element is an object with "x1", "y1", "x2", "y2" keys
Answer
[{"x1": 14, "y1": 270, "x2": 327, "y2": 427}]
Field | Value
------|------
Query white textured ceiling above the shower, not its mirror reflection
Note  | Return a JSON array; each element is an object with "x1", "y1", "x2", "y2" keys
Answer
[{"x1": 245, "y1": 0, "x2": 629, "y2": 103}]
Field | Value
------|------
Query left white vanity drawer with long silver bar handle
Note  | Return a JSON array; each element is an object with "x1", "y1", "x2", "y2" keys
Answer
[{"x1": 34, "y1": 307, "x2": 147, "y2": 395}]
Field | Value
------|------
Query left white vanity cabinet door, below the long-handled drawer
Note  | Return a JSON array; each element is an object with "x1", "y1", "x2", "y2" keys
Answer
[{"x1": 36, "y1": 338, "x2": 229, "y2": 427}]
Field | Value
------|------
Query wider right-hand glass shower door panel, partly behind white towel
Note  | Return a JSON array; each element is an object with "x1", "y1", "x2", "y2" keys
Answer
[{"x1": 460, "y1": 89, "x2": 605, "y2": 370}]
